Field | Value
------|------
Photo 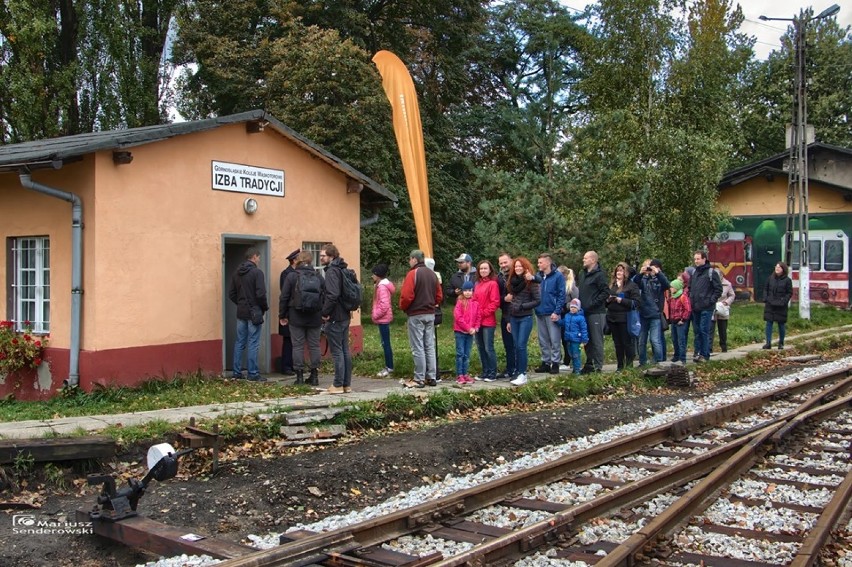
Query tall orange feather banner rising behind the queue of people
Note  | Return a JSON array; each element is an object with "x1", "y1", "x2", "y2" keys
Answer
[{"x1": 373, "y1": 51, "x2": 434, "y2": 258}]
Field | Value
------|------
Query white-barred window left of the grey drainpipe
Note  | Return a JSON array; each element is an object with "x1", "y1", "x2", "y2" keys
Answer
[{"x1": 9, "y1": 236, "x2": 50, "y2": 333}]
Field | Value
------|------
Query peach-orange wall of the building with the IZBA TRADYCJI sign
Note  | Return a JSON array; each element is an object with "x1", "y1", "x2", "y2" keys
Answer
[{"x1": 0, "y1": 124, "x2": 360, "y2": 350}]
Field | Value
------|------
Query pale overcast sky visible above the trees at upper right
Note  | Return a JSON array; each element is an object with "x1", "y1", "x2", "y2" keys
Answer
[{"x1": 561, "y1": 0, "x2": 852, "y2": 59}]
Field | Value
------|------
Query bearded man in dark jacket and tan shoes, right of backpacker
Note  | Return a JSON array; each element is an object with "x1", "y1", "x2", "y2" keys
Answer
[{"x1": 320, "y1": 244, "x2": 352, "y2": 394}]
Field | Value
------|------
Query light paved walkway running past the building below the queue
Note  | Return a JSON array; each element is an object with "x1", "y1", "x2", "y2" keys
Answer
[{"x1": 0, "y1": 325, "x2": 852, "y2": 439}]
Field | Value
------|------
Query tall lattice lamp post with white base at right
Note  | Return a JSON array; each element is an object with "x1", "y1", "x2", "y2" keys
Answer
[{"x1": 760, "y1": 4, "x2": 840, "y2": 319}]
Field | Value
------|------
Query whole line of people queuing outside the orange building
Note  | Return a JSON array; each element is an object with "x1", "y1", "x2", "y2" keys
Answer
[{"x1": 229, "y1": 244, "x2": 792, "y2": 393}]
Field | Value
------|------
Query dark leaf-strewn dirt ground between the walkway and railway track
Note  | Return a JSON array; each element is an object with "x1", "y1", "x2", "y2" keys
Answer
[{"x1": 0, "y1": 366, "x2": 816, "y2": 567}]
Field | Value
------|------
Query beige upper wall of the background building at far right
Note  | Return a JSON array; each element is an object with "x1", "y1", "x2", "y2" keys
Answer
[{"x1": 717, "y1": 177, "x2": 852, "y2": 217}]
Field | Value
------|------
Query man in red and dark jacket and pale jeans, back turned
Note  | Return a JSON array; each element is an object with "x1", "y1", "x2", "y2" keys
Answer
[{"x1": 399, "y1": 250, "x2": 444, "y2": 388}]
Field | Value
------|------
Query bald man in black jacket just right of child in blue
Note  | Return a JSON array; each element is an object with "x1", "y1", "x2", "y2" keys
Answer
[{"x1": 578, "y1": 250, "x2": 609, "y2": 374}]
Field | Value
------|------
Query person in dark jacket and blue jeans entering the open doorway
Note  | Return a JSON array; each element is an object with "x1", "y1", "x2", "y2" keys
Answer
[{"x1": 228, "y1": 248, "x2": 269, "y2": 382}]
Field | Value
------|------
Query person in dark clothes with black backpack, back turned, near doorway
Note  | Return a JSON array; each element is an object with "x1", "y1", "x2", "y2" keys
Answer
[{"x1": 278, "y1": 252, "x2": 325, "y2": 386}]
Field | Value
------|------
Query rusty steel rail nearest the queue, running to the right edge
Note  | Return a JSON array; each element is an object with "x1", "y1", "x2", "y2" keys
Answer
[{"x1": 200, "y1": 366, "x2": 852, "y2": 567}]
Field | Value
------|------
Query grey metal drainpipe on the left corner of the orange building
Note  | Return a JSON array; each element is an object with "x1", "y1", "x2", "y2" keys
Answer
[{"x1": 20, "y1": 173, "x2": 83, "y2": 386}]
